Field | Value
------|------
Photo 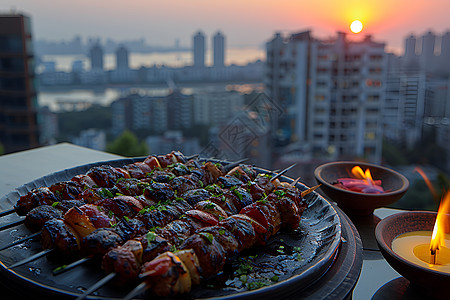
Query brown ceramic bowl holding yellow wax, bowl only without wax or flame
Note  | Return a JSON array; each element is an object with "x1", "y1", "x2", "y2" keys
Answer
[{"x1": 375, "y1": 211, "x2": 450, "y2": 298}]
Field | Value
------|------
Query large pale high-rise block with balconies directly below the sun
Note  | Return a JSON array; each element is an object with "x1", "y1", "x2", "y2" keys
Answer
[{"x1": 265, "y1": 31, "x2": 386, "y2": 162}]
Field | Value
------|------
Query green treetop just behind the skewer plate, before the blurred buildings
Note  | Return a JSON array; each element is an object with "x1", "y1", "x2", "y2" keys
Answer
[{"x1": 106, "y1": 130, "x2": 149, "y2": 157}]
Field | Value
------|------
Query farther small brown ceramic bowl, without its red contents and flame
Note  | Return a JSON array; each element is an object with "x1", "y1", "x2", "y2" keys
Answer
[{"x1": 314, "y1": 161, "x2": 409, "y2": 215}]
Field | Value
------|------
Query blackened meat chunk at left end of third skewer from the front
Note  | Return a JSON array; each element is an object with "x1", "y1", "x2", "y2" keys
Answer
[{"x1": 81, "y1": 228, "x2": 123, "y2": 256}]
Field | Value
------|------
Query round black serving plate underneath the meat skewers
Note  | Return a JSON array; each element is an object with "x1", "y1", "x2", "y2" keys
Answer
[{"x1": 0, "y1": 158, "x2": 344, "y2": 299}]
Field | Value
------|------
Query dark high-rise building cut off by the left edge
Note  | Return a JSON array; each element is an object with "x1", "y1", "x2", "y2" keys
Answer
[{"x1": 0, "y1": 14, "x2": 39, "y2": 153}]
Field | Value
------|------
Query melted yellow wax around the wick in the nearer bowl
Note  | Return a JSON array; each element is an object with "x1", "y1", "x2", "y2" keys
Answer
[{"x1": 392, "y1": 231, "x2": 450, "y2": 274}]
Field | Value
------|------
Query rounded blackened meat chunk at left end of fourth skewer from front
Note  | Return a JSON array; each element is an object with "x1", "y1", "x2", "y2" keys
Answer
[{"x1": 41, "y1": 219, "x2": 80, "y2": 255}]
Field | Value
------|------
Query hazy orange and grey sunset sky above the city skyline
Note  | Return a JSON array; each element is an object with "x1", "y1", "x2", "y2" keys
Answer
[{"x1": 0, "y1": 0, "x2": 450, "y2": 54}]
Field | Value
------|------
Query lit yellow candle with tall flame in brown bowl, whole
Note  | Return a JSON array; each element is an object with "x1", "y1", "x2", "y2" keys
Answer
[{"x1": 375, "y1": 193, "x2": 450, "y2": 294}]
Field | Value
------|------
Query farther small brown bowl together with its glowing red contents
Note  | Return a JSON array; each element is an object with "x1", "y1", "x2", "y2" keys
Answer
[{"x1": 314, "y1": 161, "x2": 409, "y2": 216}]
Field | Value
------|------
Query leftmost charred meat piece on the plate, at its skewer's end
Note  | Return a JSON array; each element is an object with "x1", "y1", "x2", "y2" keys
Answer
[{"x1": 14, "y1": 187, "x2": 60, "y2": 216}]
